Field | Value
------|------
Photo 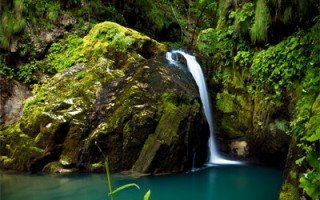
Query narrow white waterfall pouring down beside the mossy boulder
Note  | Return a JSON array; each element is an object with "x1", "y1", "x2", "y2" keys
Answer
[{"x1": 166, "y1": 50, "x2": 238, "y2": 164}]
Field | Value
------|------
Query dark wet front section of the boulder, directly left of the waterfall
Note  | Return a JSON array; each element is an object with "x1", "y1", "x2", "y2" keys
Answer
[{"x1": 86, "y1": 58, "x2": 208, "y2": 173}]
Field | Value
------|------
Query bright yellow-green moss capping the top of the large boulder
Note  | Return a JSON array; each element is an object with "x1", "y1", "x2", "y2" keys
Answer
[{"x1": 83, "y1": 22, "x2": 166, "y2": 61}]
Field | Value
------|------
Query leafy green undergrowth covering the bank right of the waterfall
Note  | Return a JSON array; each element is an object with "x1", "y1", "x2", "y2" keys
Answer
[{"x1": 198, "y1": 3, "x2": 320, "y2": 199}]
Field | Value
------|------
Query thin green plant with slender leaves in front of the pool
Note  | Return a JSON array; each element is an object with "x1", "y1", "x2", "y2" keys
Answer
[{"x1": 95, "y1": 142, "x2": 151, "y2": 200}]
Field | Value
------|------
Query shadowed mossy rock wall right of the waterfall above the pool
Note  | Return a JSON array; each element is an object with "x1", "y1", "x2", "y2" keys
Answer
[{"x1": 215, "y1": 86, "x2": 290, "y2": 167}]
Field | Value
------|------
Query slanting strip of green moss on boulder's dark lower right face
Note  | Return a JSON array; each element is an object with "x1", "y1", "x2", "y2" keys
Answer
[{"x1": 133, "y1": 92, "x2": 201, "y2": 173}]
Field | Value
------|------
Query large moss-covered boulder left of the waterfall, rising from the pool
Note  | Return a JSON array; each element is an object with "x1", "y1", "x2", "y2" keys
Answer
[{"x1": 0, "y1": 22, "x2": 208, "y2": 173}]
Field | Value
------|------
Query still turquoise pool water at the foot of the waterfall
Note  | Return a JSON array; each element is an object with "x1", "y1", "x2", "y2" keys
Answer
[{"x1": 0, "y1": 165, "x2": 282, "y2": 200}]
